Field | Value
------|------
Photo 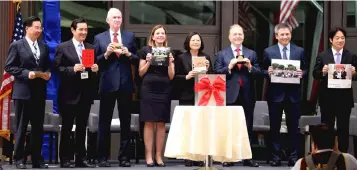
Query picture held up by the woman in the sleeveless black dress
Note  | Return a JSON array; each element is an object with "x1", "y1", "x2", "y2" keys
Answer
[{"x1": 150, "y1": 47, "x2": 170, "y2": 66}]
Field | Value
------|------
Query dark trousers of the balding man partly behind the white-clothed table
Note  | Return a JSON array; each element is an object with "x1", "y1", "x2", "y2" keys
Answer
[{"x1": 227, "y1": 87, "x2": 255, "y2": 156}]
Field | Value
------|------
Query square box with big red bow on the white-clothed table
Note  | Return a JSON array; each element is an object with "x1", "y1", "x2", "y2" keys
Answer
[{"x1": 194, "y1": 74, "x2": 226, "y2": 106}]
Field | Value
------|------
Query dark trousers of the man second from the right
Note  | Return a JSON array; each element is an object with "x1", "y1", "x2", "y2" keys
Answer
[{"x1": 268, "y1": 96, "x2": 301, "y2": 161}]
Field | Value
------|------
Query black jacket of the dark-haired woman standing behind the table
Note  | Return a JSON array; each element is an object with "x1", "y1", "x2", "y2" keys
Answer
[{"x1": 175, "y1": 51, "x2": 213, "y2": 101}]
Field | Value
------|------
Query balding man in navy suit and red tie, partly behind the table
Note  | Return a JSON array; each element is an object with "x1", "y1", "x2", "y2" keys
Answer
[{"x1": 215, "y1": 25, "x2": 260, "y2": 167}]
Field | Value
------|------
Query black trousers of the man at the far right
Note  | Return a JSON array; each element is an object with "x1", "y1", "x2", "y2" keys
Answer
[{"x1": 320, "y1": 104, "x2": 351, "y2": 152}]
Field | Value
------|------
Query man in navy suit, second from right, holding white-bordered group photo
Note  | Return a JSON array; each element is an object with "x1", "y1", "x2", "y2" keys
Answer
[{"x1": 263, "y1": 23, "x2": 308, "y2": 166}]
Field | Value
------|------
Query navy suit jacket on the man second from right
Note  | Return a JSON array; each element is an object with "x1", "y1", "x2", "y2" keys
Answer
[{"x1": 263, "y1": 43, "x2": 309, "y2": 102}]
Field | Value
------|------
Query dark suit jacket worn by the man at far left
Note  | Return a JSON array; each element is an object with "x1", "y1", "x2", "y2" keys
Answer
[{"x1": 5, "y1": 38, "x2": 51, "y2": 100}]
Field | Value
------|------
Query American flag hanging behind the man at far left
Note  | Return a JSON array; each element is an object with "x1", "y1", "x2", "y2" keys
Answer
[{"x1": 0, "y1": 2, "x2": 24, "y2": 140}]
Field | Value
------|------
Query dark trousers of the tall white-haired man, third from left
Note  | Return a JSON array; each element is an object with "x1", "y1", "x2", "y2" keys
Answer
[{"x1": 97, "y1": 91, "x2": 132, "y2": 161}]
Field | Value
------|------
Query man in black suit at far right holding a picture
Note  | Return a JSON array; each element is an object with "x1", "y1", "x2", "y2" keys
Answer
[{"x1": 313, "y1": 28, "x2": 357, "y2": 152}]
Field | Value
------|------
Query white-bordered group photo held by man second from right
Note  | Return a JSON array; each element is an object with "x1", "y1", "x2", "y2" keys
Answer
[{"x1": 270, "y1": 59, "x2": 300, "y2": 84}]
